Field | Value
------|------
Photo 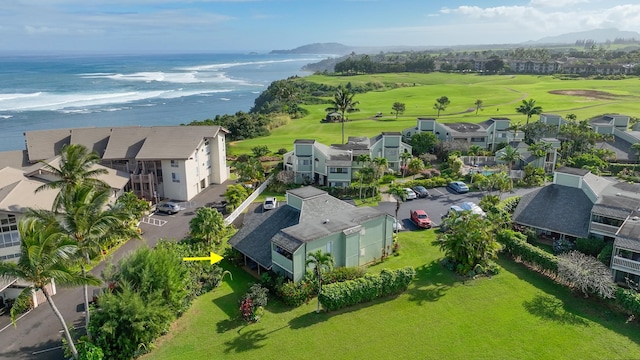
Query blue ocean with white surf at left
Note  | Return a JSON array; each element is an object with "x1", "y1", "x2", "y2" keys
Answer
[{"x1": 0, "y1": 54, "x2": 327, "y2": 151}]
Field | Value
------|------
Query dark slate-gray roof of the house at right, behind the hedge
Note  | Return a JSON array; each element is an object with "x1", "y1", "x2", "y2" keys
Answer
[{"x1": 513, "y1": 184, "x2": 593, "y2": 238}]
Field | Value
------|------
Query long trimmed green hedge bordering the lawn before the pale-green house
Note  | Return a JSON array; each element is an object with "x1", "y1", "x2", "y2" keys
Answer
[{"x1": 318, "y1": 266, "x2": 416, "y2": 311}]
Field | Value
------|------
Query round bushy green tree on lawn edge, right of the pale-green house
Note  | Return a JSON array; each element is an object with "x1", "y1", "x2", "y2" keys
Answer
[{"x1": 437, "y1": 212, "x2": 501, "y2": 275}]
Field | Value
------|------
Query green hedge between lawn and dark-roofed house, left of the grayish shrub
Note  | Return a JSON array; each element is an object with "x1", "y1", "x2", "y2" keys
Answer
[{"x1": 497, "y1": 230, "x2": 558, "y2": 274}]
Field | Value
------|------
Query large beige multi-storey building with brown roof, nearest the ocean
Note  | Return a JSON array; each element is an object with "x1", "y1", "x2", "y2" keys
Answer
[{"x1": 25, "y1": 126, "x2": 229, "y2": 202}]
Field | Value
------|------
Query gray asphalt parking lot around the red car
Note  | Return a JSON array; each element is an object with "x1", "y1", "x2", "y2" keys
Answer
[{"x1": 378, "y1": 187, "x2": 537, "y2": 230}]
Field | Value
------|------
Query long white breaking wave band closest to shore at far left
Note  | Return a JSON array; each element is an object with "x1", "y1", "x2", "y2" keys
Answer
[{"x1": 0, "y1": 89, "x2": 232, "y2": 111}]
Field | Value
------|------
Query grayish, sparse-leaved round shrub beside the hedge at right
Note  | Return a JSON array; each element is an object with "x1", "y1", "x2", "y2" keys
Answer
[{"x1": 558, "y1": 251, "x2": 617, "y2": 299}]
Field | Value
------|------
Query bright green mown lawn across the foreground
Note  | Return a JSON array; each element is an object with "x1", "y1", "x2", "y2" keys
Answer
[{"x1": 145, "y1": 231, "x2": 640, "y2": 360}]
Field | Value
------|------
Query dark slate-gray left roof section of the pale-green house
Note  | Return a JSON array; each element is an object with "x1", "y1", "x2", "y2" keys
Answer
[{"x1": 229, "y1": 205, "x2": 300, "y2": 269}]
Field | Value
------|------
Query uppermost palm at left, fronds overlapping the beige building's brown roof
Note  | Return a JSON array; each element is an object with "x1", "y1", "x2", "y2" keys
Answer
[{"x1": 36, "y1": 144, "x2": 109, "y2": 212}]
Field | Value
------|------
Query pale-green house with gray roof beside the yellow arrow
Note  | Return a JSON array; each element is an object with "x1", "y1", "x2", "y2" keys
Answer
[{"x1": 229, "y1": 186, "x2": 393, "y2": 281}]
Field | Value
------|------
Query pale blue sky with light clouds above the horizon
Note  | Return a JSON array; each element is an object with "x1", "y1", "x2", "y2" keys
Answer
[{"x1": 0, "y1": 0, "x2": 640, "y2": 53}]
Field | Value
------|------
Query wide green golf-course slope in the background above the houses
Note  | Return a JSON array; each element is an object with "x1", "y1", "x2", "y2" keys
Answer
[{"x1": 231, "y1": 73, "x2": 640, "y2": 154}]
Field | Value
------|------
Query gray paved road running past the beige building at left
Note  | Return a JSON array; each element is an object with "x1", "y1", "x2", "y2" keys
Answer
[{"x1": 0, "y1": 184, "x2": 226, "y2": 360}]
